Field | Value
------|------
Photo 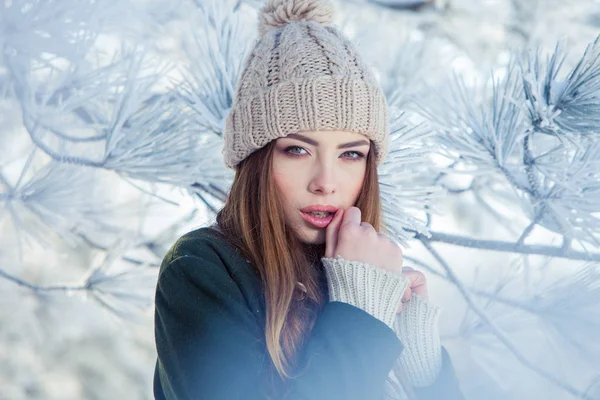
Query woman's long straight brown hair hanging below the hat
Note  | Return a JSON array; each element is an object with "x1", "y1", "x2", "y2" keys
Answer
[{"x1": 216, "y1": 140, "x2": 383, "y2": 390}]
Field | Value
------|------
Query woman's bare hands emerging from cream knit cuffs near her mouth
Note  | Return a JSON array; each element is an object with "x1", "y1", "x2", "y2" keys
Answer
[{"x1": 325, "y1": 207, "x2": 428, "y2": 313}]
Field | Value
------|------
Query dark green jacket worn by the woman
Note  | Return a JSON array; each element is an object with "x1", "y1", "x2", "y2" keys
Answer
[{"x1": 154, "y1": 227, "x2": 463, "y2": 400}]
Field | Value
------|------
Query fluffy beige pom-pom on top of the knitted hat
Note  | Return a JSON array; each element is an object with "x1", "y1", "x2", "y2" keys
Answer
[{"x1": 258, "y1": 0, "x2": 333, "y2": 36}]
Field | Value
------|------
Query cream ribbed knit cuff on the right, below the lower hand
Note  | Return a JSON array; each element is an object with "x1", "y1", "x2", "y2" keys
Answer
[{"x1": 393, "y1": 293, "x2": 442, "y2": 387}]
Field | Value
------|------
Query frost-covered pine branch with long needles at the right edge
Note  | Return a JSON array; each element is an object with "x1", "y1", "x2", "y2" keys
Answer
[{"x1": 421, "y1": 35, "x2": 600, "y2": 246}]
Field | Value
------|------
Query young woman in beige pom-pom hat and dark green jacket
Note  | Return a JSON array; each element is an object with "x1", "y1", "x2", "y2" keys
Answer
[{"x1": 154, "y1": 0, "x2": 463, "y2": 400}]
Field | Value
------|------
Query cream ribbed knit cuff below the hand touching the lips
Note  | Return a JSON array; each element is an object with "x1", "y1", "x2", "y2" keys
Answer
[{"x1": 321, "y1": 256, "x2": 410, "y2": 329}]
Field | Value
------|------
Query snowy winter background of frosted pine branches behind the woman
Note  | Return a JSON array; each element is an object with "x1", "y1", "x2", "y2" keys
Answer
[{"x1": 0, "y1": 0, "x2": 600, "y2": 400}]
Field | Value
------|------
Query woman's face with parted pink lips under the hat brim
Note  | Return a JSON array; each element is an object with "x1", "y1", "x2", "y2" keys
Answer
[{"x1": 273, "y1": 131, "x2": 371, "y2": 244}]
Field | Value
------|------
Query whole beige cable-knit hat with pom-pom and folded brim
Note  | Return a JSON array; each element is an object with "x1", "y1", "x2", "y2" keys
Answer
[{"x1": 223, "y1": 0, "x2": 388, "y2": 168}]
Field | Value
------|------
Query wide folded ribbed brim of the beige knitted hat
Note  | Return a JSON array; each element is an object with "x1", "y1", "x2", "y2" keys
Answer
[{"x1": 222, "y1": 75, "x2": 389, "y2": 168}]
